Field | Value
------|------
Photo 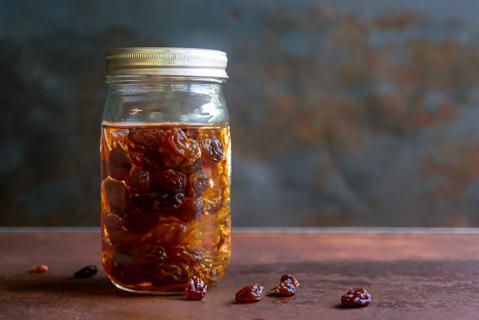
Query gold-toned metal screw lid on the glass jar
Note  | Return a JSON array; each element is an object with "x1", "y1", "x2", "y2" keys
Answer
[{"x1": 105, "y1": 47, "x2": 228, "y2": 79}]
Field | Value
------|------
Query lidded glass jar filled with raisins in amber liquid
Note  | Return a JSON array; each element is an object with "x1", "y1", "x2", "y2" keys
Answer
[{"x1": 100, "y1": 48, "x2": 231, "y2": 294}]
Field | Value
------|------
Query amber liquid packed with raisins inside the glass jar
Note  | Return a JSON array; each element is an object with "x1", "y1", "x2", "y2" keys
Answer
[{"x1": 100, "y1": 123, "x2": 231, "y2": 293}]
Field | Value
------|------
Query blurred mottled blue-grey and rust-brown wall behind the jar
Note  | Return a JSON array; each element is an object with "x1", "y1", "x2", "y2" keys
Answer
[{"x1": 0, "y1": 0, "x2": 479, "y2": 226}]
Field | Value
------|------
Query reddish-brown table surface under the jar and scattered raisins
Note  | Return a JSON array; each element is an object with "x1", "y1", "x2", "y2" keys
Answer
[{"x1": 0, "y1": 230, "x2": 479, "y2": 320}]
